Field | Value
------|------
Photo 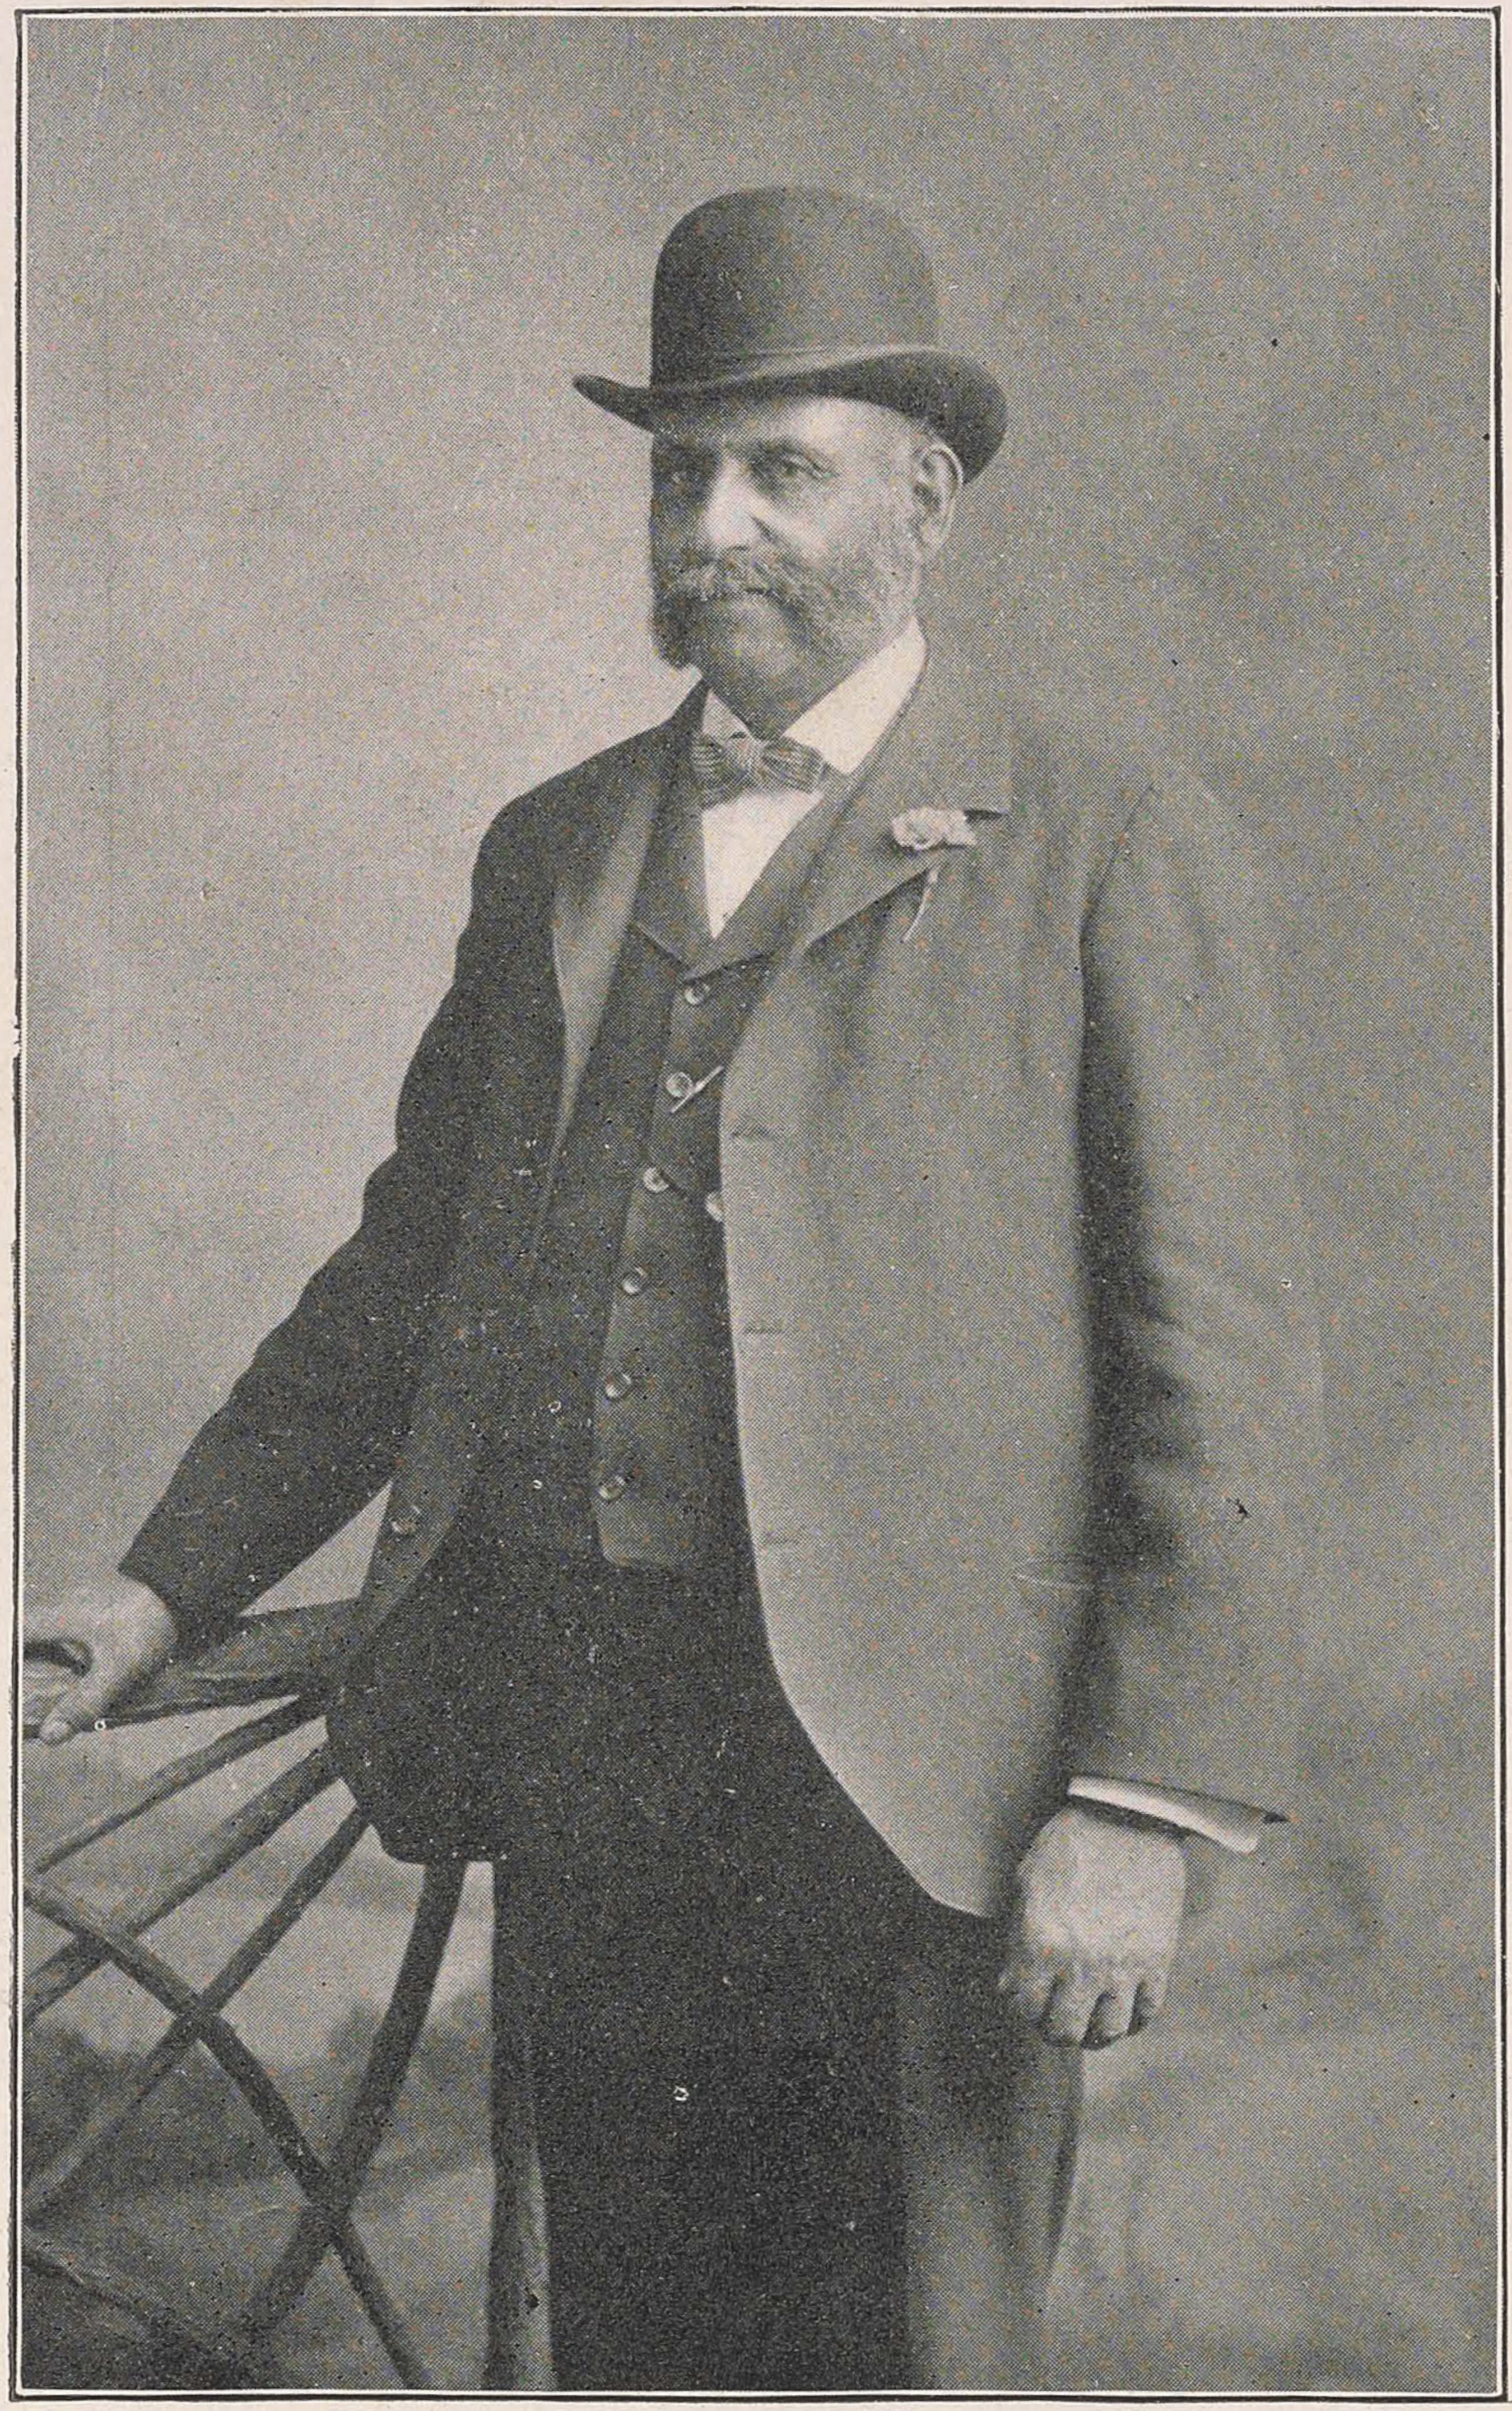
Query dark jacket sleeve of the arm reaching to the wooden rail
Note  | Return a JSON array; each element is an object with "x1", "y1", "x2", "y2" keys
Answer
[{"x1": 123, "y1": 810, "x2": 545, "y2": 1647}]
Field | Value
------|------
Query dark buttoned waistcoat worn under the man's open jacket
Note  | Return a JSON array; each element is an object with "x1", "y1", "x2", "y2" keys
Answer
[{"x1": 463, "y1": 742, "x2": 844, "y2": 1572}]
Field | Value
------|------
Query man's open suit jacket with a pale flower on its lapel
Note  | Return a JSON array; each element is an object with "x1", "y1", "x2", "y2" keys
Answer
[{"x1": 125, "y1": 658, "x2": 1316, "y2": 1912}]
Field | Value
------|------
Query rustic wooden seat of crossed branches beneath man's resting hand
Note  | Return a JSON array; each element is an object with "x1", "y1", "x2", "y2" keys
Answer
[{"x1": 22, "y1": 1603, "x2": 533, "y2": 2389}]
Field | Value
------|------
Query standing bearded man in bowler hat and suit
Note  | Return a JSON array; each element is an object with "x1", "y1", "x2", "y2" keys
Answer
[{"x1": 29, "y1": 190, "x2": 1314, "y2": 2389}]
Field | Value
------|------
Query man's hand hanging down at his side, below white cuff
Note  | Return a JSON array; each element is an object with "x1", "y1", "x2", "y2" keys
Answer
[{"x1": 998, "y1": 1808, "x2": 1187, "y2": 2049}]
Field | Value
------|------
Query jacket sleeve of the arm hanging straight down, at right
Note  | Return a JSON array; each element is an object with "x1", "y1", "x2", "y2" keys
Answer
[{"x1": 1066, "y1": 791, "x2": 1322, "y2": 1808}]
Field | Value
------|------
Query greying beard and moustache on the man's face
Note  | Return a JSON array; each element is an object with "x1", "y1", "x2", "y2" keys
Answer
[{"x1": 651, "y1": 509, "x2": 919, "y2": 699}]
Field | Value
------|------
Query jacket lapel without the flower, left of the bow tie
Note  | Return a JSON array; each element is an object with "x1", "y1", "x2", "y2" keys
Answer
[{"x1": 552, "y1": 687, "x2": 704, "y2": 1148}]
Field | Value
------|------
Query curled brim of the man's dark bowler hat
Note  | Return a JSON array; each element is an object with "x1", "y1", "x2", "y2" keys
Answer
[{"x1": 571, "y1": 347, "x2": 1008, "y2": 477}]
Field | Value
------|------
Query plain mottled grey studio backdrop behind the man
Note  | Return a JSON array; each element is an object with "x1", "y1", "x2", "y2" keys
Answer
[{"x1": 24, "y1": 12, "x2": 1495, "y2": 2392}]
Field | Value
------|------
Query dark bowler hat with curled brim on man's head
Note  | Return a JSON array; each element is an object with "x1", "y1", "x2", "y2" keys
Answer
[{"x1": 574, "y1": 185, "x2": 1008, "y2": 477}]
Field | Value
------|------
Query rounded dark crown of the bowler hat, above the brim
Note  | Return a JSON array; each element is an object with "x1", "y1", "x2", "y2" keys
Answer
[{"x1": 651, "y1": 185, "x2": 941, "y2": 386}]
